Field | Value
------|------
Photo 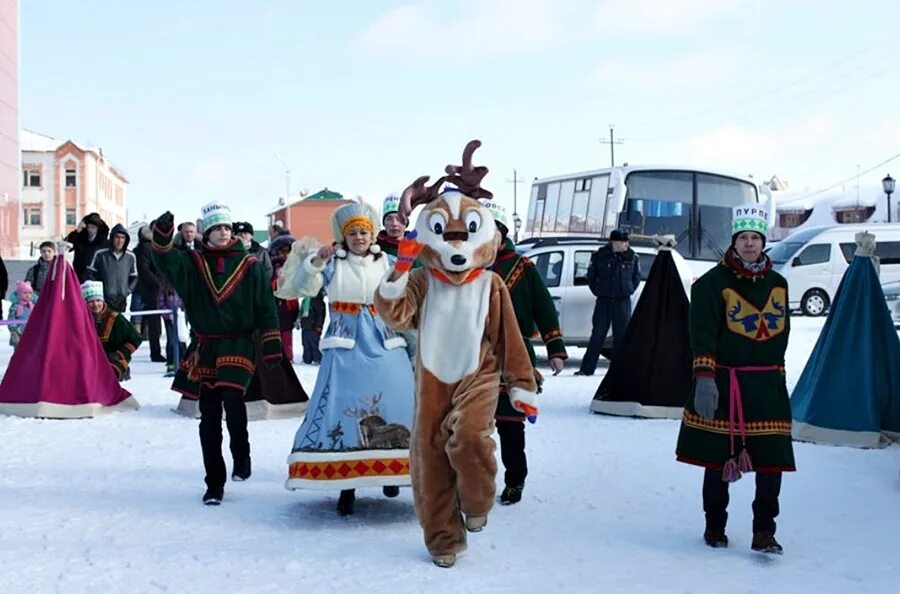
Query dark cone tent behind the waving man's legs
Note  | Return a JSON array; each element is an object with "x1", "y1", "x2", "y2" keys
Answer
[{"x1": 175, "y1": 330, "x2": 309, "y2": 421}]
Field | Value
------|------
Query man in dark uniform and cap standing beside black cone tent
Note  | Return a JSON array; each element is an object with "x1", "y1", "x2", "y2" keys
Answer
[{"x1": 575, "y1": 229, "x2": 641, "y2": 375}]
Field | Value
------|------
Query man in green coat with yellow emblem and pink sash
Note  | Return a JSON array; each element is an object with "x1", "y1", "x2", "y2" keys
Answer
[{"x1": 676, "y1": 204, "x2": 795, "y2": 554}]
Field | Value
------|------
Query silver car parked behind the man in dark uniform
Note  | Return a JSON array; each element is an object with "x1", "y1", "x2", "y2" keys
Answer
[{"x1": 517, "y1": 237, "x2": 693, "y2": 347}]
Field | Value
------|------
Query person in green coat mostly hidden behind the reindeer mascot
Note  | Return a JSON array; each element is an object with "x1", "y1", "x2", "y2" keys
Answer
[{"x1": 484, "y1": 201, "x2": 568, "y2": 505}]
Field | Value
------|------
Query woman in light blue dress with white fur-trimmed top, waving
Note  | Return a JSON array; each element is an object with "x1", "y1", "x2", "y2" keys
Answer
[{"x1": 278, "y1": 203, "x2": 414, "y2": 515}]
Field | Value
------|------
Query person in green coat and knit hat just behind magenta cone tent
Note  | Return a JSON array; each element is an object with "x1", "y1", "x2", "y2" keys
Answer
[{"x1": 81, "y1": 281, "x2": 143, "y2": 382}]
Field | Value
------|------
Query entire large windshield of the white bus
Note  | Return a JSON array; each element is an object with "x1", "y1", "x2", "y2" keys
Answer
[{"x1": 618, "y1": 171, "x2": 757, "y2": 261}]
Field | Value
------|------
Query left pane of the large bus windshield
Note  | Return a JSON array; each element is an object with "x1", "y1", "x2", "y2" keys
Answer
[{"x1": 619, "y1": 171, "x2": 694, "y2": 258}]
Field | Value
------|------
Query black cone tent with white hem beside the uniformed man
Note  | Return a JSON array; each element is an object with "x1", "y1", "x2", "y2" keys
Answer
[{"x1": 591, "y1": 235, "x2": 693, "y2": 419}]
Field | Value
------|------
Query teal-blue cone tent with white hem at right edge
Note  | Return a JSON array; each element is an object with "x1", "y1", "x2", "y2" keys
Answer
[{"x1": 791, "y1": 232, "x2": 900, "y2": 448}]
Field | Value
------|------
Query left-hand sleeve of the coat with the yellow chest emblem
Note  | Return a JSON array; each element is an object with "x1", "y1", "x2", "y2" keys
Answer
[{"x1": 690, "y1": 273, "x2": 725, "y2": 378}]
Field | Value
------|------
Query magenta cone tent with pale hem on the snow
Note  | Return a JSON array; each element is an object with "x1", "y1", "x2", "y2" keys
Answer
[{"x1": 0, "y1": 250, "x2": 138, "y2": 419}]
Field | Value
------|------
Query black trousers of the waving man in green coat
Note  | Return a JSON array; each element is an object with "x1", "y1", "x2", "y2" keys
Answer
[{"x1": 200, "y1": 387, "x2": 250, "y2": 489}]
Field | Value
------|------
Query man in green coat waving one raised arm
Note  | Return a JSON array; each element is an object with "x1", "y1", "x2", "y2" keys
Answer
[{"x1": 152, "y1": 202, "x2": 282, "y2": 505}]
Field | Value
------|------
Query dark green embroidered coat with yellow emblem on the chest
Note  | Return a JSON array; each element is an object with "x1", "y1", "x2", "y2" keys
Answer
[{"x1": 676, "y1": 251, "x2": 795, "y2": 472}]
